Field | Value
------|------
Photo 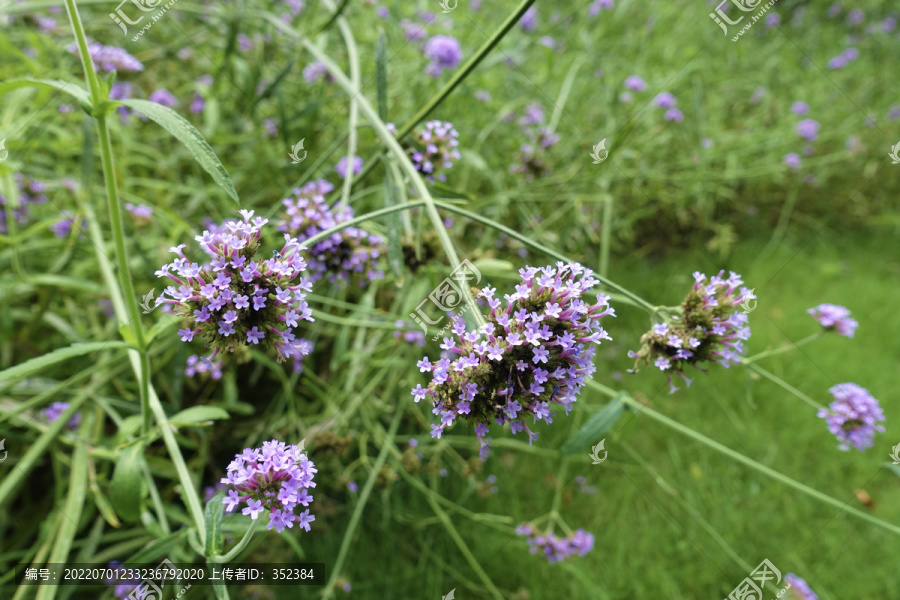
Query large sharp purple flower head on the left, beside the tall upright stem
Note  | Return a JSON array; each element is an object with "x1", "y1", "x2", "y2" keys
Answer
[{"x1": 156, "y1": 210, "x2": 315, "y2": 362}]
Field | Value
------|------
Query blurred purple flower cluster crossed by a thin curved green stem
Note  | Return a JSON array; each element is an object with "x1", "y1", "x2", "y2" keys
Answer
[{"x1": 278, "y1": 179, "x2": 385, "y2": 286}]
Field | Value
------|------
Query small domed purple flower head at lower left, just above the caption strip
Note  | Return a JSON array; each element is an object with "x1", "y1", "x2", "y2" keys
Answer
[{"x1": 221, "y1": 440, "x2": 317, "y2": 533}]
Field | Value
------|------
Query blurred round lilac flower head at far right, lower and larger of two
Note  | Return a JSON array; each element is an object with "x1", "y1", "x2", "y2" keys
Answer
[{"x1": 818, "y1": 383, "x2": 884, "y2": 452}]
